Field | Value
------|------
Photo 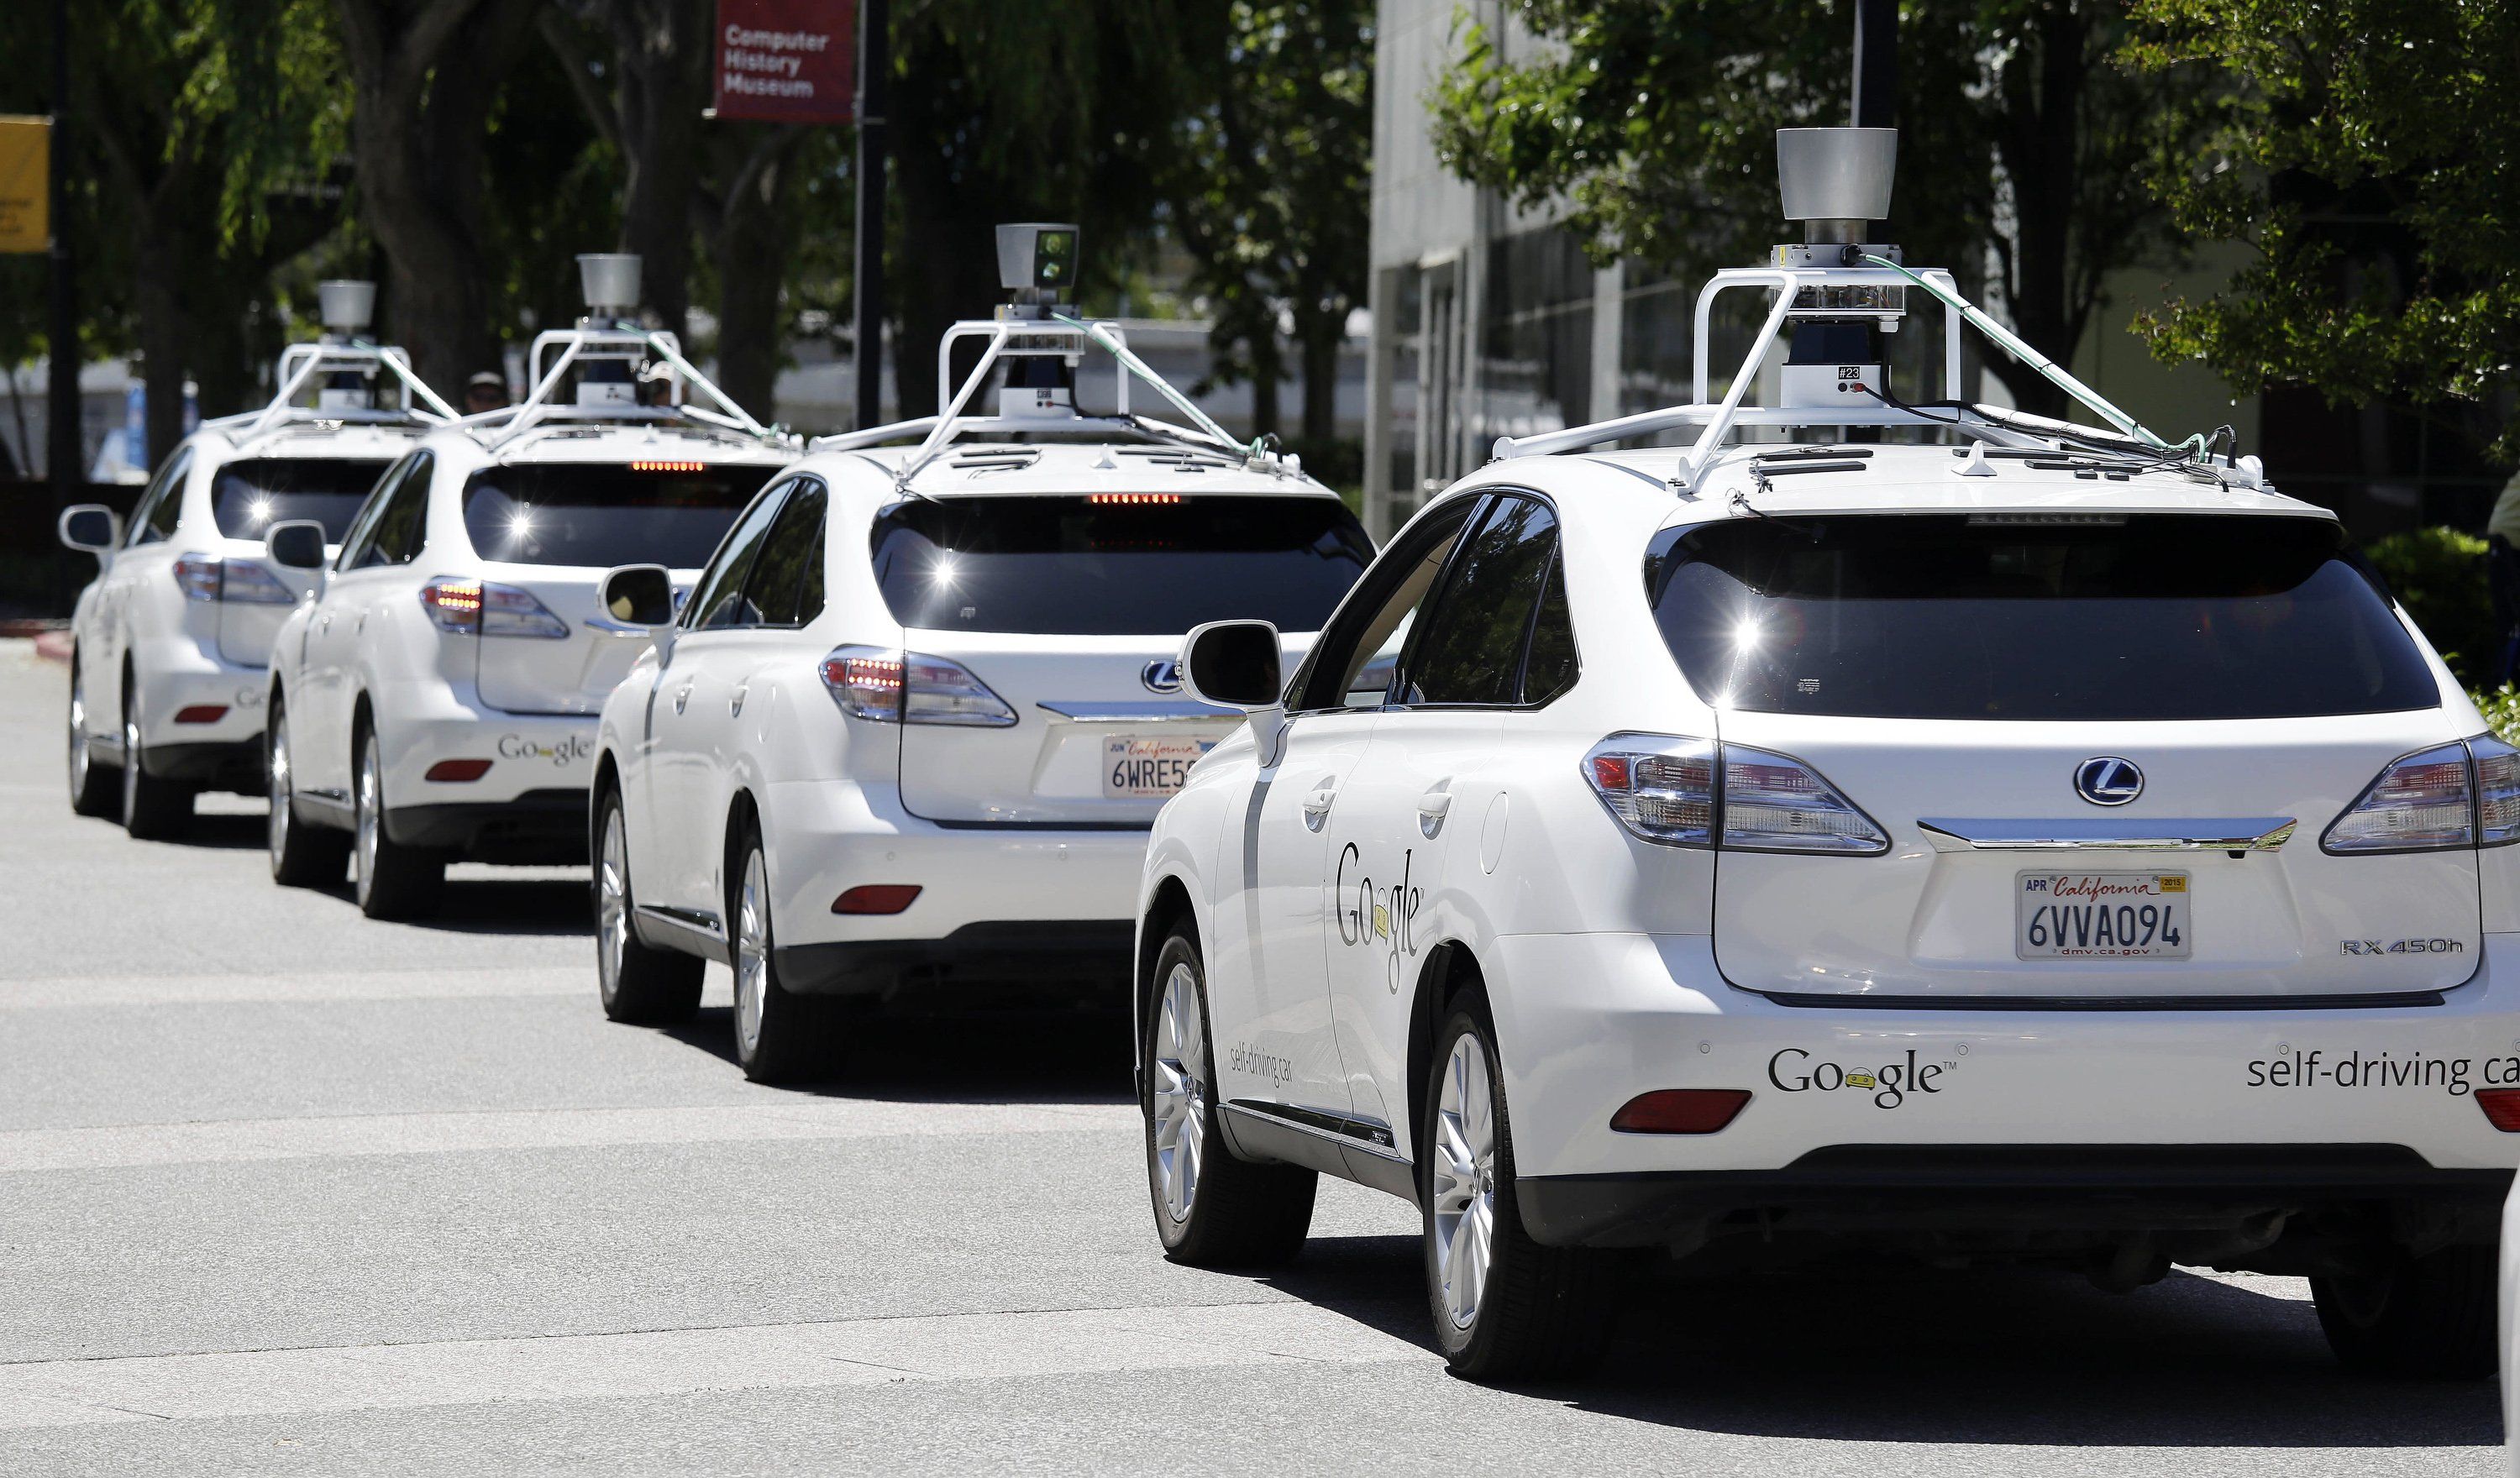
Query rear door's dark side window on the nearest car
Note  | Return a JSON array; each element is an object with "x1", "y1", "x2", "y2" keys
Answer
[{"x1": 1401, "y1": 499, "x2": 1557, "y2": 705}]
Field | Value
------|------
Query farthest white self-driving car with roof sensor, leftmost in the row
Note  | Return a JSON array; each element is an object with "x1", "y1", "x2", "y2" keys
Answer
[{"x1": 60, "y1": 282, "x2": 456, "y2": 836}]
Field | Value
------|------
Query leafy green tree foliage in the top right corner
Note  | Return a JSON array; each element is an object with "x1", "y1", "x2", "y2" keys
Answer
[{"x1": 2132, "y1": 0, "x2": 2520, "y2": 461}]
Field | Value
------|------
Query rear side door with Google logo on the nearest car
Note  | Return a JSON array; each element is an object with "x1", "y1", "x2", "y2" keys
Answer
[{"x1": 1328, "y1": 494, "x2": 1572, "y2": 1150}]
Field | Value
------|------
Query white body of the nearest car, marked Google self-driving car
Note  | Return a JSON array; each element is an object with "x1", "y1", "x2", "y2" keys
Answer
[{"x1": 1137, "y1": 440, "x2": 2520, "y2": 1380}]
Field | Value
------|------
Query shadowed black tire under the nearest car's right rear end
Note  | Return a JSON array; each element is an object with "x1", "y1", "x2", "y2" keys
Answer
[{"x1": 2311, "y1": 1246, "x2": 2497, "y2": 1380}]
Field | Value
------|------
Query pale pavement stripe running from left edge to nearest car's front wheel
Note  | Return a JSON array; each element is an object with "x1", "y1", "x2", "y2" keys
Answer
[{"x1": 0, "y1": 1098, "x2": 1137, "y2": 1176}]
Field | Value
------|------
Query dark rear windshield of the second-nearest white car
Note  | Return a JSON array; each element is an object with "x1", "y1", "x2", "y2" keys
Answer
[{"x1": 874, "y1": 494, "x2": 1373, "y2": 635}]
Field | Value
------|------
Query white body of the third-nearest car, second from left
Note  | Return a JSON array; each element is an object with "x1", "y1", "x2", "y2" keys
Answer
[{"x1": 270, "y1": 421, "x2": 791, "y2": 891}]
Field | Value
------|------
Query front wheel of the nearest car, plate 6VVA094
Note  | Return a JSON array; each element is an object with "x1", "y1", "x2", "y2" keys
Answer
[{"x1": 1139, "y1": 931, "x2": 1320, "y2": 1266}]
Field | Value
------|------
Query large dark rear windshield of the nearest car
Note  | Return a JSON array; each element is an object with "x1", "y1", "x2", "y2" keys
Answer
[{"x1": 1646, "y1": 514, "x2": 2439, "y2": 721}]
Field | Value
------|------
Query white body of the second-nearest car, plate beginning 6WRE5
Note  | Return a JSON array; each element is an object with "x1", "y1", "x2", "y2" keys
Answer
[{"x1": 592, "y1": 441, "x2": 1371, "y2": 1030}]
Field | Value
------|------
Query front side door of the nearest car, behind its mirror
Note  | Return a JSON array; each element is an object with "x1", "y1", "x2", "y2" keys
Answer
[{"x1": 1212, "y1": 490, "x2": 1467, "y2": 1133}]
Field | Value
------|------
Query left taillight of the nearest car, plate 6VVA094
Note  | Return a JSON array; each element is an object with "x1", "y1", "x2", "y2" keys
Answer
[{"x1": 1583, "y1": 733, "x2": 1890, "y2": 856}]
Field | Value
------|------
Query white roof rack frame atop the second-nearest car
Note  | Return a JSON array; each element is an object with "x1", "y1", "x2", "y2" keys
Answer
[{"x1": 811, "y1": 315, "x2": 1303, "y2": 489}]
